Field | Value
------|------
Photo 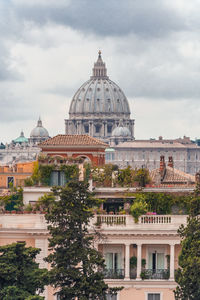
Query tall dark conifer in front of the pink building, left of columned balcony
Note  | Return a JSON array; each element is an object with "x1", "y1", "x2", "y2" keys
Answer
[{"x1": 41, "y1": 181, "x2": 121, "y2": 300}]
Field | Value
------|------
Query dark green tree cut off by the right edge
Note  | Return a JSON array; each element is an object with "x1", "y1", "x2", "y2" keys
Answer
[{"x1": 174, "y1": 216, "x2": 200, "y2": 300}]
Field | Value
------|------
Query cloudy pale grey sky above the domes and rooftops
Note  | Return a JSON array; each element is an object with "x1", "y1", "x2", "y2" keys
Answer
[{"x1": 0, "y1": 0, "x2": 200, "y2": 143}]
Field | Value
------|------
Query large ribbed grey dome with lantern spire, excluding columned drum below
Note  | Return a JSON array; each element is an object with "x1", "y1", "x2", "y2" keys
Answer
[{"x1": 69, "y1": 51, "x2": 130, "y2": 118}]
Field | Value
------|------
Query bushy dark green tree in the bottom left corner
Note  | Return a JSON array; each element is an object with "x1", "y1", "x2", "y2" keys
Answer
[{"x1": 0, "y1": 242, "x2": 48, "y2": 300}]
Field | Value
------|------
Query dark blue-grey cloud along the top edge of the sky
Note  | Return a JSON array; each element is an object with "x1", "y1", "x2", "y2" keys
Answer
[{"x1": 13, "y1": 0, "x2": 185, "y2": 38}]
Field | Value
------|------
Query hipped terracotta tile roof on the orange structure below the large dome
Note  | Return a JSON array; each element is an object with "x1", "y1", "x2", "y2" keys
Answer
[{"x1": 39, "y1": 134, "x2": 108, "y2": 148}]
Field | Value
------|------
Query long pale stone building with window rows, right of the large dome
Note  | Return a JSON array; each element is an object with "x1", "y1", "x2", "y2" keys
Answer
[{"x1": 106, "y1": 136, "x2": 200, "y2": 175}]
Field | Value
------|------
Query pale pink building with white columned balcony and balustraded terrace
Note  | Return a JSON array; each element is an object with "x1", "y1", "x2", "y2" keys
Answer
[{"x1": 0, "y1": 187, "x2": 193, "y2": 300}]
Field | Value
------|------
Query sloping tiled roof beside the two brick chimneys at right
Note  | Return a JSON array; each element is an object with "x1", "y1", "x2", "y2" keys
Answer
[{"x1": 150, "y1": 166, "x2": 195, "y2": 184}]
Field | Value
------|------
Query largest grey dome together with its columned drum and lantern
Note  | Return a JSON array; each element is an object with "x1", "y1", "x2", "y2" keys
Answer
[{"x1": 65, "y1": 51, "x2": 134, "y2": 143}]
